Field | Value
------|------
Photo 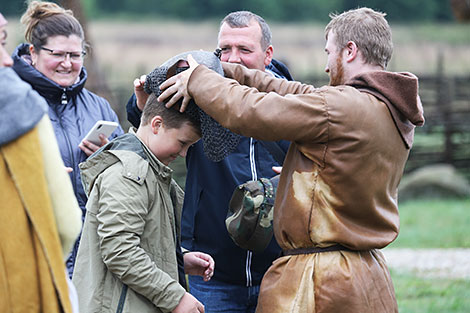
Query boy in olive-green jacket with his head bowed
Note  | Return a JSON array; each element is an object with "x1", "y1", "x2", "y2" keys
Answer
[{"x1": 73, "y1": 94, "x2": 214, "y2": 313}]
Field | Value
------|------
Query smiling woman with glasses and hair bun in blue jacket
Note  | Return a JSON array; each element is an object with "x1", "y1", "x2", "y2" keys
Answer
[{"x1": 12, "y1": 1, "x2": 123, "y2": 277}]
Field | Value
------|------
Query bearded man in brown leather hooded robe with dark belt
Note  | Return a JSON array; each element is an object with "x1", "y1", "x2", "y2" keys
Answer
[{"x1": 159, "y1": 8, "x2": 424, "y2": 313}]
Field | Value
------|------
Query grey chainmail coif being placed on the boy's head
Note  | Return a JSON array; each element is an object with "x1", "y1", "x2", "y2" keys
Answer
[{"x1": 144, "y1": 51, "x2": 241, "y2": 162}]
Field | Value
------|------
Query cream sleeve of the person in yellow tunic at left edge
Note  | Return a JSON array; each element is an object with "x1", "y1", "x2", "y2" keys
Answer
[{"x1": 37, "y1": 115, "x2": 82, "y2": 260}]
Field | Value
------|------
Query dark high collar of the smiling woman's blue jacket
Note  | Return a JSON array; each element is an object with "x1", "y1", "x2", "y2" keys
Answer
[{"x1": 13, "y1": 43, "x2": 88, "y2": 104}]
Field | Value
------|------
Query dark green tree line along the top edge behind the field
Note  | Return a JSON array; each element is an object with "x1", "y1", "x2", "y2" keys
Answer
[{"x1": 1, "y1": 0, "x2": 453, "y2": 22}]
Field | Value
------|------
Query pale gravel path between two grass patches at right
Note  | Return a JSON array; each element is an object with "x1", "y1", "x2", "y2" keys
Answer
[{"x1": 382, "y1": 248, "x2": 470, "y2": 279}]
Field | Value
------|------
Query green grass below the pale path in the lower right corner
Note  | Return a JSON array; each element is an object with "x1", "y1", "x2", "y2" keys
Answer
[{"x1": 391, "y1": 270, "x2": 470, "y2": 313}]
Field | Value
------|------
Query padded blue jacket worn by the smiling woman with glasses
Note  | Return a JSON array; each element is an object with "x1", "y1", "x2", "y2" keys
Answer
[{"x1": 12, "y1": 44, "x2": 123, "y2": 274}]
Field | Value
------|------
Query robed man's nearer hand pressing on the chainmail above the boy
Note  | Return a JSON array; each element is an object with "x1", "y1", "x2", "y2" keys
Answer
[{"x1": 157, "y1": 54, "x2": 199, "y2": 112}]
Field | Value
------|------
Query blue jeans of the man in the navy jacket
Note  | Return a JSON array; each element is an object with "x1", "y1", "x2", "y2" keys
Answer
[{"x1": 189, "y1": 276, "x2": 259, "y2": 313}]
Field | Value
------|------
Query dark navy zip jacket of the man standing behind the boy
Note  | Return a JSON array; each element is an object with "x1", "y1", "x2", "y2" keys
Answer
[{"x1": 127, "y1": 59, "x2": 292, "y2": 286}]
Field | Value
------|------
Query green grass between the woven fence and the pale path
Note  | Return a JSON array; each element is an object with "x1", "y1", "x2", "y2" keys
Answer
[{"x1": 390, "y1": 199, "x2": 470, "y2": 248}]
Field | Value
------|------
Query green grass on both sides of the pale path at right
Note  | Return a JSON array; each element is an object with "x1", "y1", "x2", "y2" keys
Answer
[{"x1": 390, "y1": 199, "x2": 470, "y2": 313}]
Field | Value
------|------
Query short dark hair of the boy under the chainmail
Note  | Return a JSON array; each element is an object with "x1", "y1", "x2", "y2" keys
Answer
[{"x1": 141, "y1": 93, "x2": 201, "y2": 135}]
